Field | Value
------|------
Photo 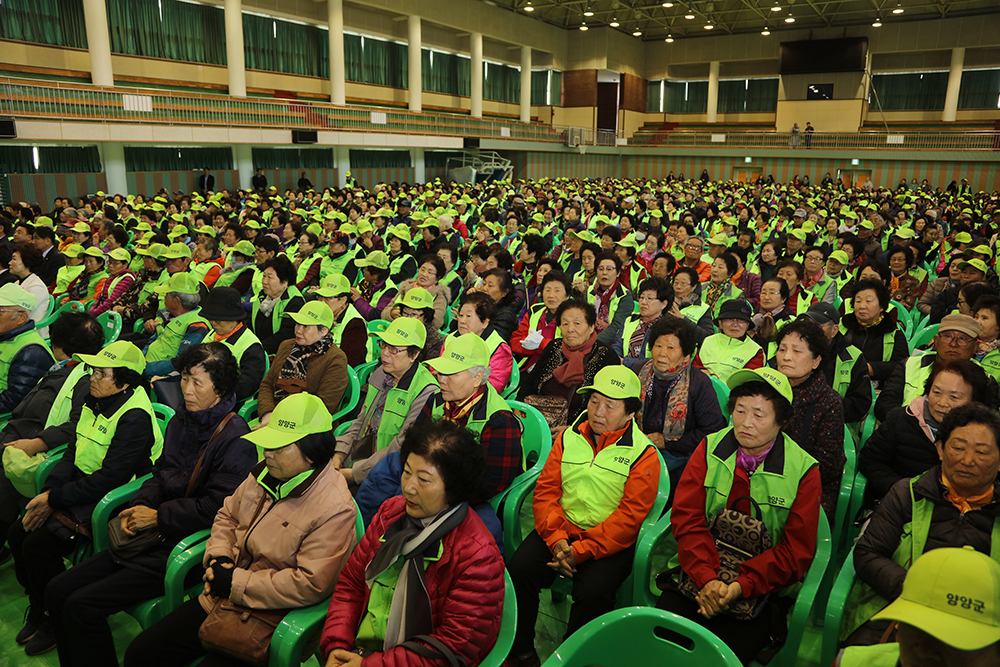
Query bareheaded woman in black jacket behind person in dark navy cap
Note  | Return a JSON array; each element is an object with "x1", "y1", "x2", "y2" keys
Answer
[{"x1": 841, "y1": 278, "x2": 910, "y2": 383}]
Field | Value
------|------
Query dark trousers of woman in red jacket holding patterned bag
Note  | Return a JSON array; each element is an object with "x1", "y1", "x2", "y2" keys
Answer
[{"x1": 656, "y1": 590, "x2": 787, "y2": 665}]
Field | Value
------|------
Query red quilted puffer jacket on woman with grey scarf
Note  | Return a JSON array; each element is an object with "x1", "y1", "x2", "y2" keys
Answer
[{"x1": 320, "y1": 496, "x2": 504, "y2": 667}]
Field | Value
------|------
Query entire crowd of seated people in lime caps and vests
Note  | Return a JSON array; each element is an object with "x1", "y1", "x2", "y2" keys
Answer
[{"x1": 0, "y1": 177, "x2": 1000, "y2": 667}]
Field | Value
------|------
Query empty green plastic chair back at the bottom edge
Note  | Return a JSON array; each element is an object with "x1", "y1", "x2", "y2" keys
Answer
[{"x1": 543, "y1": 607, "x2": 740, "y2": 667}]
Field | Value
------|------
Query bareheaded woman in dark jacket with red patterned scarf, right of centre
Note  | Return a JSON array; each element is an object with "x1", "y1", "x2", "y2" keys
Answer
[{"x1": 638, "y1": 315, "x2": 726, "y2": 488}]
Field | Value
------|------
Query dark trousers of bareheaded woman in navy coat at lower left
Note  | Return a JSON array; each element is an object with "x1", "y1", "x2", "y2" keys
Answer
[{"x1": 45, "y1": 551, "x2": 163, "y2": 667}]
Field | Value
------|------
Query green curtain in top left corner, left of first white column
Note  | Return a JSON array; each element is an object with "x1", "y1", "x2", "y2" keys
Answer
[{"x1": 0, "y1": 0, "x2": 87, "y2": 49}]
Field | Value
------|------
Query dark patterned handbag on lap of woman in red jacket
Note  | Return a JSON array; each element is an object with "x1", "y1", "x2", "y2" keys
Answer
[{"x1": 657, "y1": 496, "x2": 771, "y2": 620}]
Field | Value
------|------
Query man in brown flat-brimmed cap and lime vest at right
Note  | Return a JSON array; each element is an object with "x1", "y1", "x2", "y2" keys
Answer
[{"x1": 875, "y1": 313, "x2": 979, "y2": 421}]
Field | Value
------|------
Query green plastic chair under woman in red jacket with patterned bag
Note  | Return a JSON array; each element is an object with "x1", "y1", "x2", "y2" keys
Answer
[{"x1": 632, "y1": 510, "x2": 832, "y2": 667}]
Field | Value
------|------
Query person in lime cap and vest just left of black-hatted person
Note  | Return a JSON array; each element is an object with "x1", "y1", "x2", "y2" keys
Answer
[{"x1": 142, "y1": 273, "x2": 209, "y2": 379}]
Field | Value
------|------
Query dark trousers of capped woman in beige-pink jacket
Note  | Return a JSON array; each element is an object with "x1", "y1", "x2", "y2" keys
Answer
[{"x1": 125, "y1": 598, "x2": 246, "y2": 667}]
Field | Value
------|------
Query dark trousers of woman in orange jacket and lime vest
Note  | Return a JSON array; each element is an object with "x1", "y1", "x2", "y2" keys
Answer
[{"x1": 507, "y1": 530, "x2": 635, "y2": 655}]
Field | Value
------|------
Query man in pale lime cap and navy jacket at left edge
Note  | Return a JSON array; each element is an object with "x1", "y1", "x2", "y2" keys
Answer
[{"x1": 0, "y1": 283, "x2": 54, "y2": 412}]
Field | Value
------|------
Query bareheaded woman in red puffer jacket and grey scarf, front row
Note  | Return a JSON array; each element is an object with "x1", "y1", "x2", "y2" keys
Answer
[{"x1": 320, "y1": 420, "x2": 505, "y2": 667}]
